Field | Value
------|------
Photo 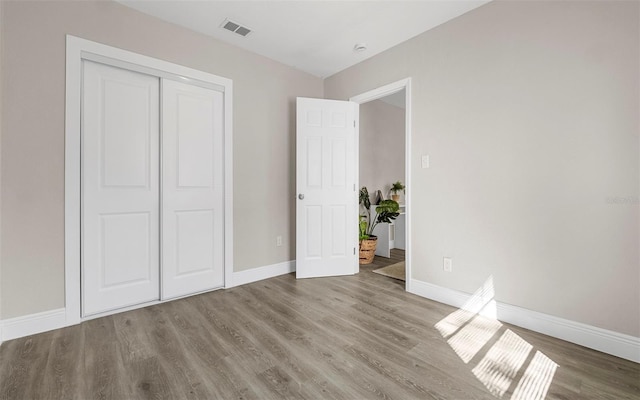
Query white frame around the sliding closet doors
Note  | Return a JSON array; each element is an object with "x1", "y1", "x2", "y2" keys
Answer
[{"x1": 64, "y1": 35, "x2": 233, "y2": 325}]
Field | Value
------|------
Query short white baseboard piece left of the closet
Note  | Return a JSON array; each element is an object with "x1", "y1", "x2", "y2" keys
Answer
[{"x1": 0, "y1": 308, "x2": 67, "y2": 342}]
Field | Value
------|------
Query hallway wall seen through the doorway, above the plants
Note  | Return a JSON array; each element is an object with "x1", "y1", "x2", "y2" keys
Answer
[{"x1": 359, "y1": 99, "x2": 405, "y2": 202}]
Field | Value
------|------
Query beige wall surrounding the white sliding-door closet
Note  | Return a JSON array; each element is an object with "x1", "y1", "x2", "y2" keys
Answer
[{"x1": 0, "y1": 1, "x2": 323, "y2": 319}]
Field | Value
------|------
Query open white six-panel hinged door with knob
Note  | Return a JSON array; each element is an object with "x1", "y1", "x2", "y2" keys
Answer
[{"x1": 296, "y1": 97, "x2": 359, "y2": 278}]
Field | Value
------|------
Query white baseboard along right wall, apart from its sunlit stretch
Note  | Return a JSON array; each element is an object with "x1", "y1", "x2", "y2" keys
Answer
[{"x1": 410, "y1": 279, "x2": 640, "y2": 363}]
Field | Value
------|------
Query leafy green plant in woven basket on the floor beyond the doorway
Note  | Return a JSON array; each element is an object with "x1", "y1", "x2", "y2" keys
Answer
[{"x1": 358, "y1": 186, "x2": 400, "y2": 264}]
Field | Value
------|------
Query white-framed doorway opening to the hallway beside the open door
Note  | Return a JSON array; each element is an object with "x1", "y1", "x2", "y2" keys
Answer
[{"x1": 350, "y1": 78, "x2": 411, "y2": 291}]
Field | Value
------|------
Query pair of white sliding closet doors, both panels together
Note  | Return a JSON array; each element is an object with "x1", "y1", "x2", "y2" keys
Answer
[{"x1": 80, "y1": 59, "x2": 225, "y2": 317}]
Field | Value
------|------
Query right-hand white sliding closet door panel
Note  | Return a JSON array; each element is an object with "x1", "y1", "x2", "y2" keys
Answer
[{"x1": 162, "y1": 80, "x2": 224, "y2": 299}]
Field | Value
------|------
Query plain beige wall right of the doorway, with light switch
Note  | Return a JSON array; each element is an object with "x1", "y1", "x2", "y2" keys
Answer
[{"x1": 325, "y1": 1, "x2": 640, "y2": 337}]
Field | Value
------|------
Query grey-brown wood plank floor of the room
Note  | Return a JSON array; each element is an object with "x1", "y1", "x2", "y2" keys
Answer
[{"x1": 0, "y1": 252, "x2": 640, "y2": 399}]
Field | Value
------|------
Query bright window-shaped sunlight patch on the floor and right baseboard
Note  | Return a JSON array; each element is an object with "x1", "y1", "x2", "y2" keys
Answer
[{"x1": 435, "y1": 276, "x2": 558, "y2": 400}]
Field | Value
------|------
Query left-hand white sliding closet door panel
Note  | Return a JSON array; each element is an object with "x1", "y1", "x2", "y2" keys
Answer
[{"x1": 81, "y1": 61, "x2": 160, "y2": 315}]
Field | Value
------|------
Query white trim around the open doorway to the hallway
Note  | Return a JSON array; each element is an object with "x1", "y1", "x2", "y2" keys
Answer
[{"x1": 349, "y1": 78, "x2": 412, "y2": 292}]
